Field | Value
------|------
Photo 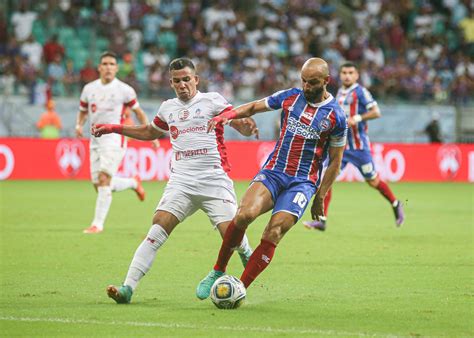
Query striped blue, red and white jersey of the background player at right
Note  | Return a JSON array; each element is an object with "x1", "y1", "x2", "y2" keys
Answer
[{"x1": 336, "y1": 83, "x2": 377, "y2": 150}]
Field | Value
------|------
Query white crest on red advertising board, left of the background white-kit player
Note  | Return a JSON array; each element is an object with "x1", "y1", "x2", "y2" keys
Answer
[{"x1": 56, "y1": 139, "x2": 86, "y2": 177}]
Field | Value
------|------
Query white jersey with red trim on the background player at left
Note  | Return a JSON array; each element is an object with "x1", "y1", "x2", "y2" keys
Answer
[{"x1": 79, "y1": 79, "x2": 139, "y2": 148}]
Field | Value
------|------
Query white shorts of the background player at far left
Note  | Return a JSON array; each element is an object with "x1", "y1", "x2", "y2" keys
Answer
[{"x1": 90, "y1": 148, "x2": 126, "y2": 183}]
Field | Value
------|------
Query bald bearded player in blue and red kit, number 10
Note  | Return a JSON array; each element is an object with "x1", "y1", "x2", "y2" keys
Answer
[{"x1": 196, "y1": 58, "x2": 347, "y2": 299}]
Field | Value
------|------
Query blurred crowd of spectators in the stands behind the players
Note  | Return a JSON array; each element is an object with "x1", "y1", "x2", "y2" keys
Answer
[{"x1": 0, "y1": 0, "x2": 474, "y2": 105}]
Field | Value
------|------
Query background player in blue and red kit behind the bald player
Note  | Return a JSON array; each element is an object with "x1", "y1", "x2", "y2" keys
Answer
[{"x1": 303, "y1": 62, "x2": 405, "y2": 230}]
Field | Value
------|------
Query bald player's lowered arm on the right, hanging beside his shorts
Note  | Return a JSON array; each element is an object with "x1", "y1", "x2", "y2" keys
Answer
[{"x1": 311, "y1": 146, "x2": 345, "y2": 220}]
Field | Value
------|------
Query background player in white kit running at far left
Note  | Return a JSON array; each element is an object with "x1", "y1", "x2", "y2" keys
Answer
[{"x1": 76, "y1": 52, "x2": 157, "y2": 234}]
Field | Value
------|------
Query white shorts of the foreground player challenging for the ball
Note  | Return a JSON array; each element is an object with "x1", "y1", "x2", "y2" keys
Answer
[{"x1": 156, "y1": 182, "x2": 237, "y2": 227}]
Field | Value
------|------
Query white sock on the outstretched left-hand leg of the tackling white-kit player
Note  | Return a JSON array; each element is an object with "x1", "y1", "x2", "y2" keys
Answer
[{"x1": 123, "y1": 224, "x2": 168, "y2": 290}]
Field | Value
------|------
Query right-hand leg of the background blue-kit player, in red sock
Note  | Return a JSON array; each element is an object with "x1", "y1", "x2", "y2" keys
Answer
[{"x1": 353, "y1": 151, "x2": 405, "y2": 226}]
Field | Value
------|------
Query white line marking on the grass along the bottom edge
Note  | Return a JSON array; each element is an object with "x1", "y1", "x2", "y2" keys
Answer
[{"x1": 0, "y1": 316, "x2": 397, "y2": 337}]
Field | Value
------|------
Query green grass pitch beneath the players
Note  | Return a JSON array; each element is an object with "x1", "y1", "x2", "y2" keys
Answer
[{"x1": 0, "y1": 181, "x2": 474, "y2": 337}]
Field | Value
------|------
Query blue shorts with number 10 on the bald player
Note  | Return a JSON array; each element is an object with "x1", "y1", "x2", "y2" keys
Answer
[{"x1": 252, "y1": 169, "x2": 316, "y2": 219}]
